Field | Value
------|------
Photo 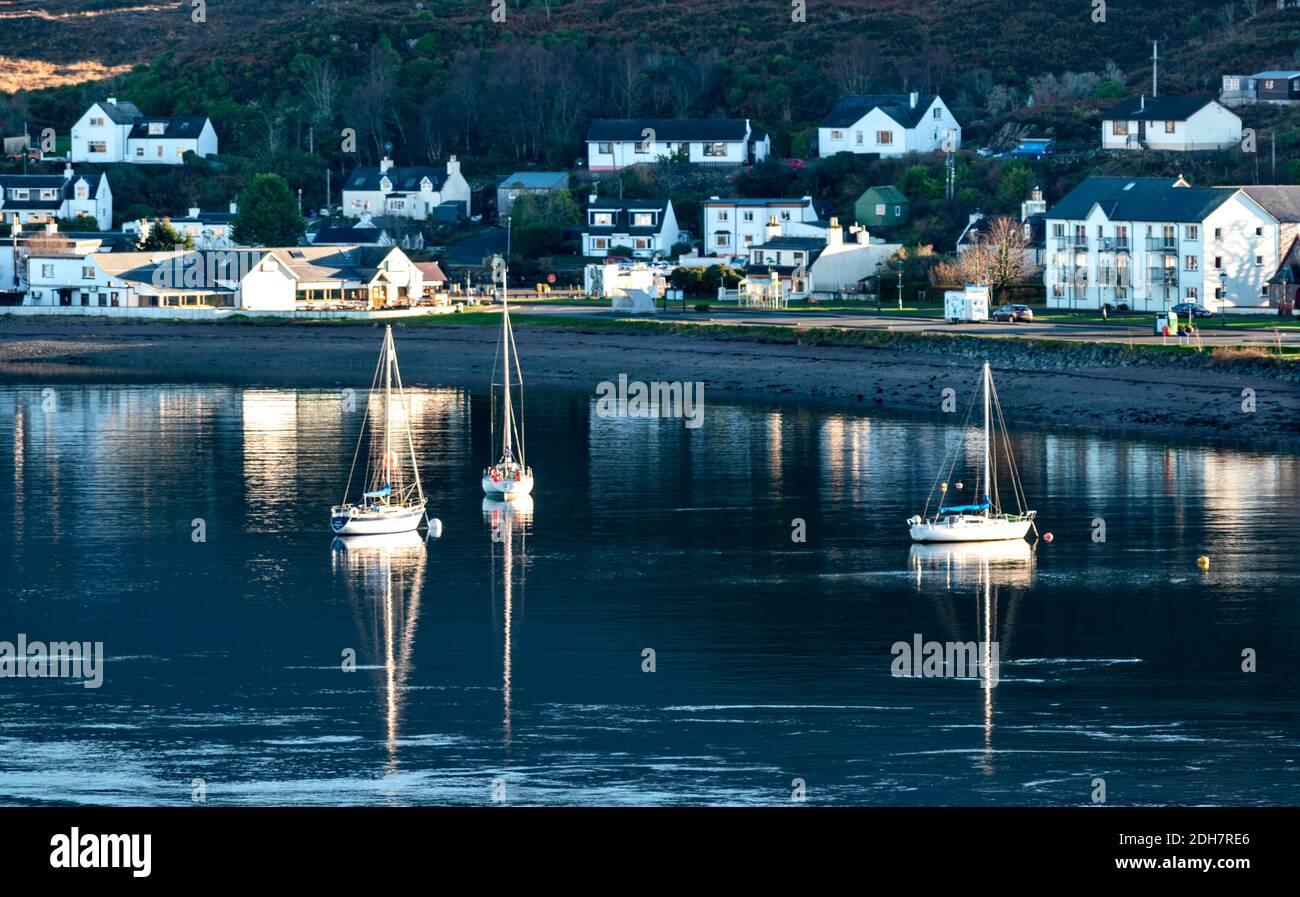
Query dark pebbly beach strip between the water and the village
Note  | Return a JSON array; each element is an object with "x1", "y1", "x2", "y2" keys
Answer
[{"x1": 0, "y1": 317, "x2": 1300, "y2": 452}]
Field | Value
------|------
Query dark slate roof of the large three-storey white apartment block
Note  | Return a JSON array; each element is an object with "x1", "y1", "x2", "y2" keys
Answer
[{"x1": 1047, "y1": 178, "x2": 1236, "y2": 221}]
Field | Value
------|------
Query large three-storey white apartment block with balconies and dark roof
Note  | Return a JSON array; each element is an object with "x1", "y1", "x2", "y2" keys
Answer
[{"x1": 1044, "y1": 177, "x2": 1281, "y2": 312}]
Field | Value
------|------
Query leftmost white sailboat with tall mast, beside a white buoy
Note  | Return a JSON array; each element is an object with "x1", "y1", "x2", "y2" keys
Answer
[{"x1": 329, "y1": 325, "x2": 428, "y2": 536}]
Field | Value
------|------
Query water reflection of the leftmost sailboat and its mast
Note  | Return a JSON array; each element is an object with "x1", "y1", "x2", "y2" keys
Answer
[{"x1": 330, "y1": 530, "x2": 428, "y2": 776}]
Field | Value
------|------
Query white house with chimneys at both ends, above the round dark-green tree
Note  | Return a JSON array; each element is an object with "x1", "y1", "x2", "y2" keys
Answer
[{"x1": 343, "y1": 156, "x2": 469, "y2": 224}]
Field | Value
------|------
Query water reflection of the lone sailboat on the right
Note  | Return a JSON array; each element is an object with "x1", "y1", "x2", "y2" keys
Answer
[{"x1": 907, "y1": 540, "x2": 1034, "y2": 775}]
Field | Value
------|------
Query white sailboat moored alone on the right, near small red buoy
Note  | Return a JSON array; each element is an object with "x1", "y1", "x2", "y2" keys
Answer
[{"x1": 907, "y1": 361, "x2": 1037, "y2": 542}]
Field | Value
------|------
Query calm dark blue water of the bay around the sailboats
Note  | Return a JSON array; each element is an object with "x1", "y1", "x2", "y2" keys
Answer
[{"x1": 0, "y1": 385, "x2": 1300, "y2": 805}]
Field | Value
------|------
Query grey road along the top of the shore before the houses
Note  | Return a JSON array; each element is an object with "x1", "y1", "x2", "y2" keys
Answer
[{"x1": 504, "y1": 303, "x2": 1300, "y2": 347}]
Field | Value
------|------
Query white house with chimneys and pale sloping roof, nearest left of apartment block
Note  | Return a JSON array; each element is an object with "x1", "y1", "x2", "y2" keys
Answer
[{"x1": 745, "y1": 216, "x2": 900, "y2": 295}]
